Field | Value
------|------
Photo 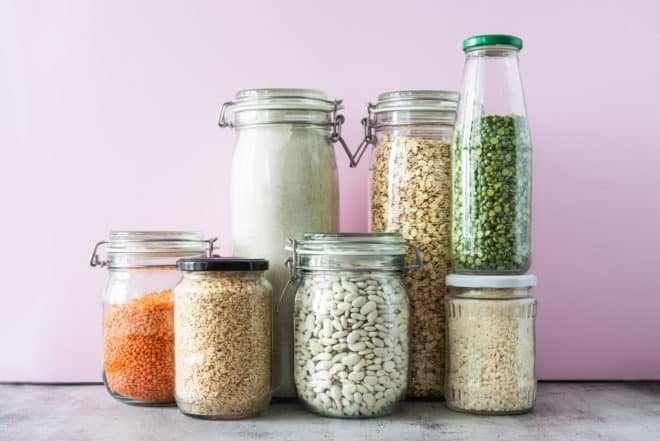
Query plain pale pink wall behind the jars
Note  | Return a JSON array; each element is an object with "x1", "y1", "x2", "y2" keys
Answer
[{"x1": 0, "y1": 0, "x2": 660, "y2": 381}]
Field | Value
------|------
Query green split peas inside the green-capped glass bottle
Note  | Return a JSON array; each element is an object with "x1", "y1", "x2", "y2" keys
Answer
[{"x1": 452, "y1": 115, "x2": 532, "y2": 273}]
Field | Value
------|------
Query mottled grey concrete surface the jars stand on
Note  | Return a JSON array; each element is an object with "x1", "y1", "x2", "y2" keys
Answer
[{"x1": 0, "y1": 383, "x2": 660, "y2": 441}]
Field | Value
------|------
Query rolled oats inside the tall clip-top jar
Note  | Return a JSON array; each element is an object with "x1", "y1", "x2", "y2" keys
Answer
[{"x1": 371, "y1": 133, "x2": 451, "y2": 397}]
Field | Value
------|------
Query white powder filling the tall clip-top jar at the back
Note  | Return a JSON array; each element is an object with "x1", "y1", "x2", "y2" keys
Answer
[{"x1": 231, "y1": 124, "x2": 339, "y2": 397}]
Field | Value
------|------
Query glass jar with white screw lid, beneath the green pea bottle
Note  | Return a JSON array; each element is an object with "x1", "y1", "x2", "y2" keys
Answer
[{"x1": 445, "y1": 274, "x2": 536, "y2": 415}]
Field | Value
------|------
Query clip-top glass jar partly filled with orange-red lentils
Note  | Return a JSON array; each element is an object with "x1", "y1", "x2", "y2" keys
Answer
[{"x1": 90, "y1": 231, "x2": 216, "y2": 405}]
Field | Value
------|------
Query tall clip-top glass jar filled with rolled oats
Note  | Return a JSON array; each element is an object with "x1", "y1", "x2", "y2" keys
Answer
[{"x1": 357, "y1": 90, "x2": 458, "y2": 399}]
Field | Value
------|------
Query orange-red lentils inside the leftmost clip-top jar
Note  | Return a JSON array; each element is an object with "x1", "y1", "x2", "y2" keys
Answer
[{"x1": 105, "y1": 289, "x2": 174, "y2": 402}]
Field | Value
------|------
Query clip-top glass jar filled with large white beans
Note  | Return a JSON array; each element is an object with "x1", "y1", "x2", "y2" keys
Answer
[{"x1": 287, "y1": 233, "x2": 421, "y2": 418}]
